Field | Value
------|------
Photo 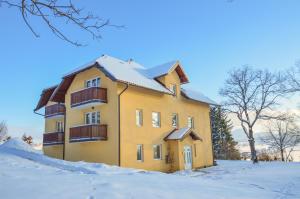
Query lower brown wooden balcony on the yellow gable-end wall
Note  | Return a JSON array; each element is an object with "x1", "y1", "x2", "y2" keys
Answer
[{"x1": 70, "y1": 124, "x2": 107, "y2": 142}]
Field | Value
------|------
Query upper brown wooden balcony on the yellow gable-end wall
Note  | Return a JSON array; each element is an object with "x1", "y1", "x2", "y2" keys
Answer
[{"x1": 71, "y1": 87, "x2": 107, "y2": 108}]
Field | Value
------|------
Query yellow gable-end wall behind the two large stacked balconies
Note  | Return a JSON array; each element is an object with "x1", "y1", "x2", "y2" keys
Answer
[{"x1": 65, "y1": 68, "x2": 118, "y2": 165}]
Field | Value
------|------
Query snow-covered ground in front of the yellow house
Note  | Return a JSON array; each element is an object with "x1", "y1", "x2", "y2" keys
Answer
[{"x1": 0, "y1": 139, "x2": 300, "y2": 199}]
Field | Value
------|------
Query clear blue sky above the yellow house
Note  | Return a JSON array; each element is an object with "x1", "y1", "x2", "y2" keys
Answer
[{"x1": 0, "y1": 0, "x2": 300, "y2": 141}]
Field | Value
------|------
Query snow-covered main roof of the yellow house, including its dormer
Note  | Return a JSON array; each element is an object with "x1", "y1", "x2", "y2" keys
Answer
[{"x1": 44, "y1": 55, "x2": 217, "y2": 105}]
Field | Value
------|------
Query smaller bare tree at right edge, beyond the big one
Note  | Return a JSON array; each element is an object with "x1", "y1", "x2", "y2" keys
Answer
[{"x1": 261, "y1": 116, "x2": 300, "y2": 161}]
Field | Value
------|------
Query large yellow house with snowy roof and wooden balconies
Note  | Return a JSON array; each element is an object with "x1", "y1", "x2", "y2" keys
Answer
[{"x1": 35, "y1": 55, "x2": 216, "y2": 172}]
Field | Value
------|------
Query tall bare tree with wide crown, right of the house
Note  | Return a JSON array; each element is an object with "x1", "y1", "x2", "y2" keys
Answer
[{"x1": 220, "y1": 66, "x2": 286, "y2": 163}]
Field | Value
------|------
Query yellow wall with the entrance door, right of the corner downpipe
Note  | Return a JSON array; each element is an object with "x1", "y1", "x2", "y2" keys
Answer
[{"x1": 121, "y1": 71, "x2": 213, "y2": 172}]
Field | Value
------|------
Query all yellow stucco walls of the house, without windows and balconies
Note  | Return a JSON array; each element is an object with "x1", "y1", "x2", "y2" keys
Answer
[{"x1": 44, "y1": 65, "x2": 213, "y2": 172}]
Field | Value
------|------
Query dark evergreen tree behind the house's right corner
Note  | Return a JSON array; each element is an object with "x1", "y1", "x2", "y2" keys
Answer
[{"x1": 210, "y1": 107, "x2": 240, "y2": 160}]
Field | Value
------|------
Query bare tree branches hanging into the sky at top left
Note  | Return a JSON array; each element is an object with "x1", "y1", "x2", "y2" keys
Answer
[{"x1": 0, "y1": 0, "x2": 120, "y2": 46}]
